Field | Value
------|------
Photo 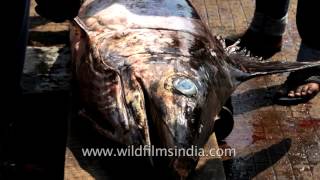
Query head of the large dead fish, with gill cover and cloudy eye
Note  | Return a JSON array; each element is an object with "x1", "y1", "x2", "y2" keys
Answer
[{"x1": 72, "y1": 22, "x2": 234, "y2": 177}]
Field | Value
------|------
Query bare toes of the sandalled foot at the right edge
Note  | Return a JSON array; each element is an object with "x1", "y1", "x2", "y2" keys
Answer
[{"x1": 288, "y1": 83, "x2": 320, "y2": 97}]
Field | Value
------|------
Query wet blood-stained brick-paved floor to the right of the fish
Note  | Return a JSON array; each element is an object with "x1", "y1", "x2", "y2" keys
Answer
[{"x1": 200, "y1": 0, "x2": 320, "y2": 180}]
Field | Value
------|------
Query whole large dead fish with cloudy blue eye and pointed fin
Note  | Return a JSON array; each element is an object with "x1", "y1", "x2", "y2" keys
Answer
[{"x1": 71, "y1": 0, "x2": 319, "y2": 177}]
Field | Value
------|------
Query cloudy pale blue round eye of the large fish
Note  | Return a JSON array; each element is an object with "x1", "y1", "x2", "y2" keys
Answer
[{"x1": 173, "y1": 78, "x2": 198, "y2": 96}]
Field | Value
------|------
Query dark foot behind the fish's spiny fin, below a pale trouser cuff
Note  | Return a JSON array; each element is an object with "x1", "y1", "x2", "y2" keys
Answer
[{"x1": 226, "y1": 29, "x2": 282, "y2": 59}]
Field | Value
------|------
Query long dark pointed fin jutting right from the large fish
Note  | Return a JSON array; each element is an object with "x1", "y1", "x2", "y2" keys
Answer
[{"x1": 229, "y1": 53, "x2": 320, "y2": 83}]
